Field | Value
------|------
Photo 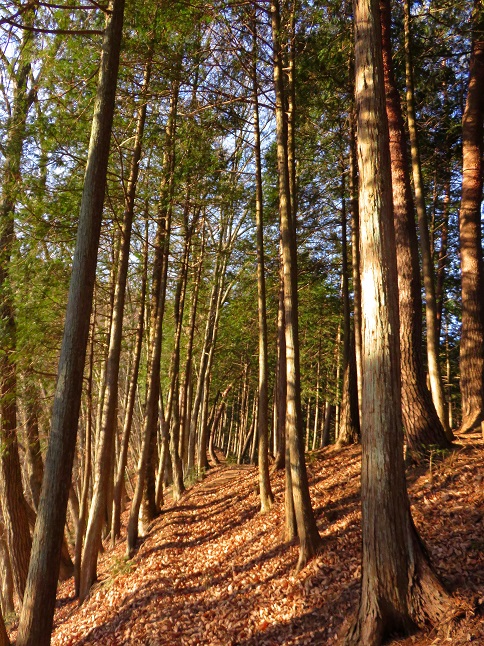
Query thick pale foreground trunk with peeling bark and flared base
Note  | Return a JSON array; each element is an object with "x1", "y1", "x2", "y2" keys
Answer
[{"x1": 346, "y1": 0, "x2": 451, "y2": 646}]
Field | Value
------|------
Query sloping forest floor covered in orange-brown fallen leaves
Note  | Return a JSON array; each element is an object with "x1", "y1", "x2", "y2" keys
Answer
[{"x1": 6, "y1": 436, "x2": 484, "y2": 646}]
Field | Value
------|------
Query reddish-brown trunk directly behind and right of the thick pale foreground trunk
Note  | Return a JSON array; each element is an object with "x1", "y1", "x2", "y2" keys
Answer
[{"x1": 380, "y1": 0, "x2": 450, "y2": 460}]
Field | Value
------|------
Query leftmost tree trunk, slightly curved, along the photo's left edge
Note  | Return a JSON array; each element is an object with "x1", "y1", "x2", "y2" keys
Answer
[{"x1": 0, "y1": 8, "x2": 35, "y2": 603}]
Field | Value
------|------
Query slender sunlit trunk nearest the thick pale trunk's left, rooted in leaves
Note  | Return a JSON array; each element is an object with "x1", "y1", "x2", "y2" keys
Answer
[{"x1": 271, "y1": 0, "x2": 321, "y2": 569}]
